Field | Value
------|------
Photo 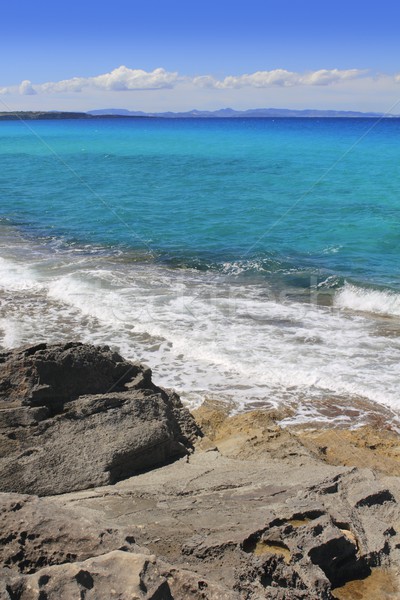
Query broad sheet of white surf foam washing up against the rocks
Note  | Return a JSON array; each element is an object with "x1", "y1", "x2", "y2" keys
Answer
[{"x1": 0, "y1": 246, "x2": 400, "y2": 424}]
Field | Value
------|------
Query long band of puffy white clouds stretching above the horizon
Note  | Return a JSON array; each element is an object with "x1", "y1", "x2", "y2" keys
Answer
[{"x1": 0, "y1": 66, "x2": 376, "y2": 96}]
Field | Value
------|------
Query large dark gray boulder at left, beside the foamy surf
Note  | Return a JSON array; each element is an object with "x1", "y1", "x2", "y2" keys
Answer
[{"x1": 0, "y1": 343, "x2": 199, "y2": 495}]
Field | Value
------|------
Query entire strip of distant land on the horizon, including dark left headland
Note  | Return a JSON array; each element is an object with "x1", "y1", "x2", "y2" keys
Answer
[{"x1": 0, "y1": 108, "x2": 400, "y2": 121}]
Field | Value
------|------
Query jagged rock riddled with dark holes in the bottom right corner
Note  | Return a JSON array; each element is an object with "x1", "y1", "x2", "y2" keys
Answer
[{"x1": 233, "y1": 480, "x2": 399, "y2": 600}]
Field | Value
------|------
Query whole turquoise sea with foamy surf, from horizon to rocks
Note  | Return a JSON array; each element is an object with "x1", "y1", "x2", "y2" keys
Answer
[{"x1": 0, "y1": 118, "x2": 400, "y2": 428}]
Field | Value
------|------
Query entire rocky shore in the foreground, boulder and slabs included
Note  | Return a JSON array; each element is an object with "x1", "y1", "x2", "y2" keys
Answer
[{"x1": 0, "y1": 343, "x2": 400, "y2": 600}]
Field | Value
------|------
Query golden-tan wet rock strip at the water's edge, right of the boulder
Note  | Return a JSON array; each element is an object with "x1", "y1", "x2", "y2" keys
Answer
[{"x1": 192, "y1": 401, "x2": 400, "y2": 477}]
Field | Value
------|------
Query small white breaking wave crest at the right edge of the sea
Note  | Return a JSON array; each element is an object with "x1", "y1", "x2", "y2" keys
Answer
[{"x1": 334, "y1": 283, "x2": 400, "y2": 317}]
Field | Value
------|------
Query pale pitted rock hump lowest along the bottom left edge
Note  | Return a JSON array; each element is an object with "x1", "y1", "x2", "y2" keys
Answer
[{"x1": 0, "y1": 550, "x2": 239, "y2": 600}]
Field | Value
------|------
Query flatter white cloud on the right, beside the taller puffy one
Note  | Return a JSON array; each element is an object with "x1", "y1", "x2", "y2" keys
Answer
[{"x1": 193, "y1": 69, "x2": 366, "y2": 89}]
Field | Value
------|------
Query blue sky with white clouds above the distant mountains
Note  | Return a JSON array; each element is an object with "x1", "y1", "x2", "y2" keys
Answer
[{"x1": 0, "y1": 0, "x2": 400, "y2": 114}]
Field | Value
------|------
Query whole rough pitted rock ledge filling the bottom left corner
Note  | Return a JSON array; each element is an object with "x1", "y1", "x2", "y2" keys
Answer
[{"x1": 0, "y1": 493, "x2": 236, "y2": 600}]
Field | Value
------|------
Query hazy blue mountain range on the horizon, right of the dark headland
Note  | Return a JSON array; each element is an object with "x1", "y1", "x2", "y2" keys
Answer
[{"x1": 88, "y1": 108, "x2": 398, "y2": 119}]
